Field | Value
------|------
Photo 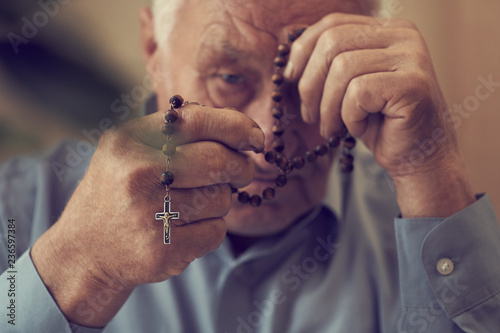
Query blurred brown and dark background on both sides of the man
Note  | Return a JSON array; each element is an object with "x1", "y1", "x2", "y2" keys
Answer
[{"x1": 0, "y1": 0, "x2": 500, "y2": 216}]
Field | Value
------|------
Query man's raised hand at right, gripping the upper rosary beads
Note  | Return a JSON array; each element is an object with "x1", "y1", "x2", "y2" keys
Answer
[{"x1": 285, "y1": 14, "x2": 474, "y2": 217}]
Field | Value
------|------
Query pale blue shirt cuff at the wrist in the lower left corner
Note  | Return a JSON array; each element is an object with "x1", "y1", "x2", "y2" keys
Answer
[{"x1": 0, "y1": 249, "x2": 102, "y2": 333}]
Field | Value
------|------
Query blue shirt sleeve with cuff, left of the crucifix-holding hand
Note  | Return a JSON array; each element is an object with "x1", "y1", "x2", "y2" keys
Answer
[{"x1": 0, "y1": 141, "x2": 97, "y2": 333}]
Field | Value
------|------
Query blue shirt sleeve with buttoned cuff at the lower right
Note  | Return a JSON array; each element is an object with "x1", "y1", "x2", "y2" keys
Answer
[{"x1": 395, "y1": 195, "x2": 500, "y2": 333}]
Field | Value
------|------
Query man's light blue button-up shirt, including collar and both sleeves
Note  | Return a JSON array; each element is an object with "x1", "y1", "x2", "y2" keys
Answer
[{"x1": 0, "y1": 136, "x2": 500, "y2": 333}]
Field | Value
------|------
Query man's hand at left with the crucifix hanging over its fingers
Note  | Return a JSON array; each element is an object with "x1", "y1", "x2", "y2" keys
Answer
[{"x1": 31, "y1": 104, "x2": 264, "y2": 327}]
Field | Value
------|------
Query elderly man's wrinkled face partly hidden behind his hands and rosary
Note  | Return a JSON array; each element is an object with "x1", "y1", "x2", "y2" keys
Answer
[{"x1": 149, "y1": 0, "x2": 359, "y2": 236}]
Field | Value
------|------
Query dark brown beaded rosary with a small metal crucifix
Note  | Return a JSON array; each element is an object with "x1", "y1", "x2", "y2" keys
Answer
[{"x1": 155, "y1": 28, "x2": 356, "y2": 244}]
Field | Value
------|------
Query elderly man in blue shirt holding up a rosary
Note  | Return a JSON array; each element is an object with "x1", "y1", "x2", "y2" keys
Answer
[{"x1": 0, "y1": 0, "x2": 500, "y2": 333}]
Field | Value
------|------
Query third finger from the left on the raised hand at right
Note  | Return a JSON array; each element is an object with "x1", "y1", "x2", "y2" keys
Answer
[{"x1": 318, "y1": 49, "x2": 404, "y2": 137}]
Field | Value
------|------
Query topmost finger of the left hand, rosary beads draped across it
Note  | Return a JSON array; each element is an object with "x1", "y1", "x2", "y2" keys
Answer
[{"x1": 122, "y1": 103, "x2": 264, "y2": 151}]
